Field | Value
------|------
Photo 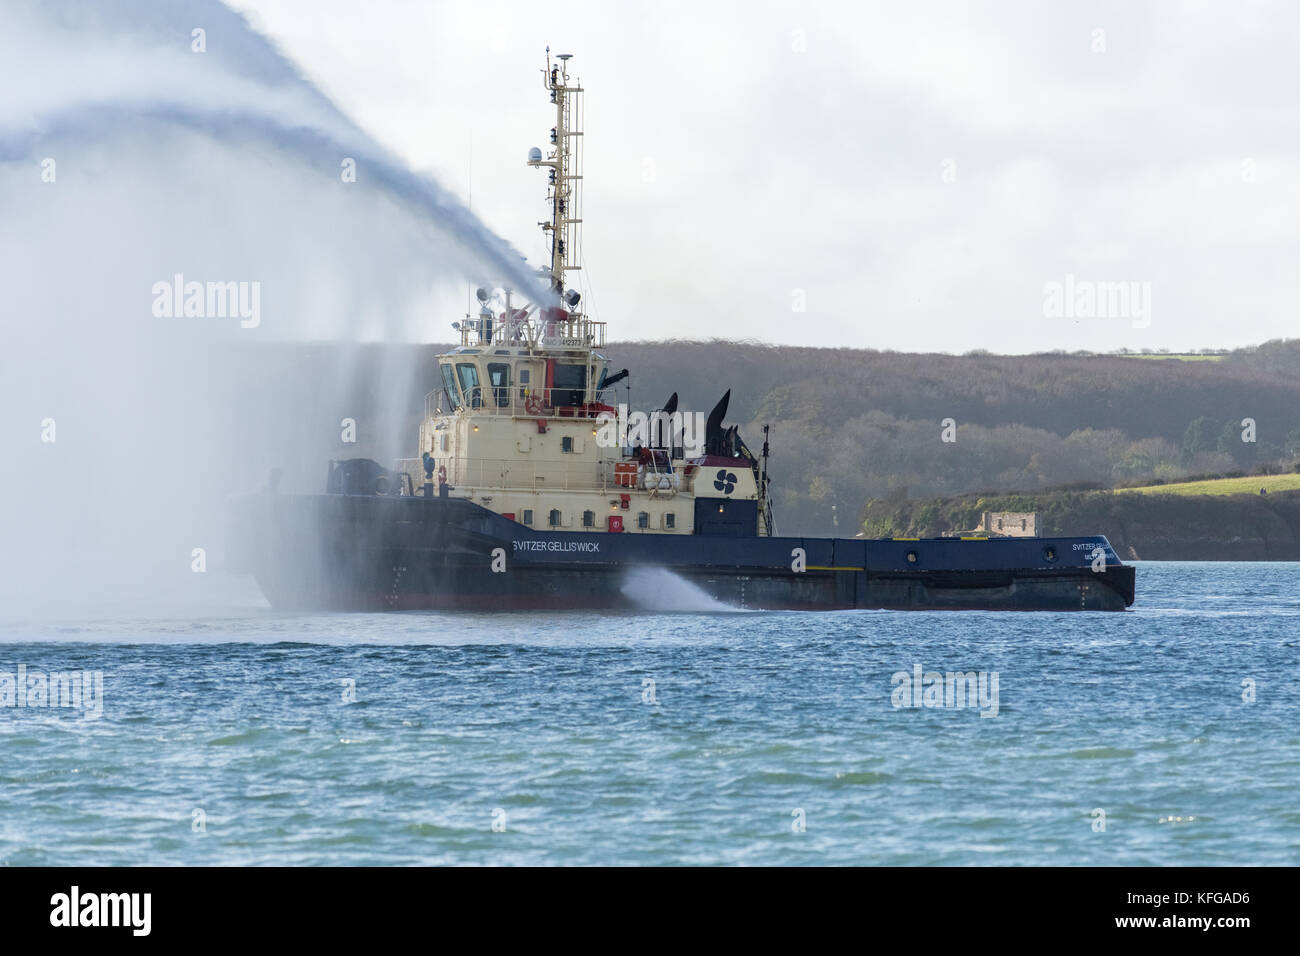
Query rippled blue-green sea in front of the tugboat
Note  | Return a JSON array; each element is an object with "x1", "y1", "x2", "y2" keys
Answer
[{"x1": 0, "y1": 562, "x2": 1300, "y2": 866}]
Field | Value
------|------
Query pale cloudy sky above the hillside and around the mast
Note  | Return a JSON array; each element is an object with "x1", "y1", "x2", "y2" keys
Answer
[{"x1": 223, "y1": 0, "x2": 1300, "y2": 352}]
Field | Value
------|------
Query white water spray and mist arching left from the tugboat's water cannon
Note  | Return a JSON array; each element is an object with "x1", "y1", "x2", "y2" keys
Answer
[{"x1": 0, "y1": 0, "x2": 546, "y2": 618}]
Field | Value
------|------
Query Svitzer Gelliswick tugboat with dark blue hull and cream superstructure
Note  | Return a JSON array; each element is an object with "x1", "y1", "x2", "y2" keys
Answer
[{"x1": 233, "y1": 49, "x2": 1134, "y2": 610}]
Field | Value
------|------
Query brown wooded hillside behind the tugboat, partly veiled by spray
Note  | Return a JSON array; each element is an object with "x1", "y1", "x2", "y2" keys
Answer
[{"x1": 223, "y1": 341, "x2": 1300, "y2": 535}]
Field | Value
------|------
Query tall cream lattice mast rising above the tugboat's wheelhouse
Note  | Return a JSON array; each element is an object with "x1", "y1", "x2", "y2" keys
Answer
[{"x1": 528, "y1": 47, "x2": 582, "y2": 308}]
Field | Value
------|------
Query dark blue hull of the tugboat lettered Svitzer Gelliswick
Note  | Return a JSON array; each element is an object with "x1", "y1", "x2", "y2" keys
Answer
[{"x1": 231, "y1": 494, "x2": 1134, "y2": 610}]
